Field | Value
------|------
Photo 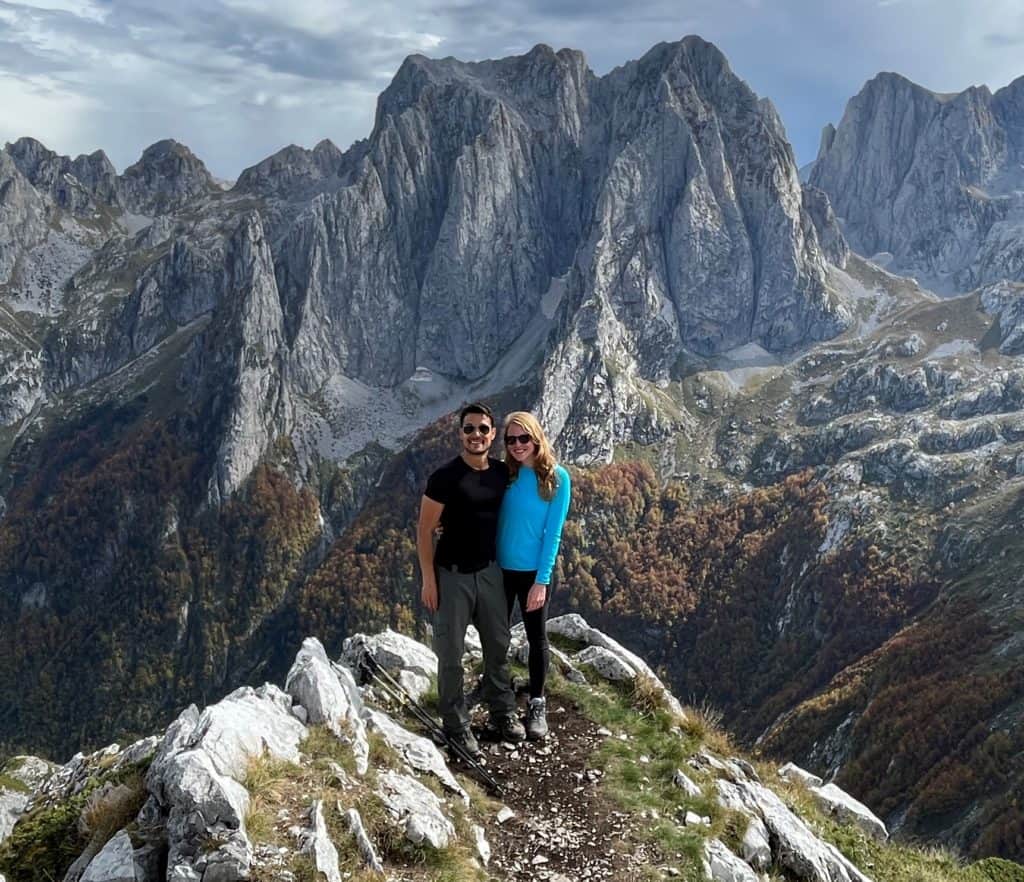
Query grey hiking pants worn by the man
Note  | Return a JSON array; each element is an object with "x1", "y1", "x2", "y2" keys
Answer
[{"x1": 433, "y1": 562, "x2": 515, "y2": 732}]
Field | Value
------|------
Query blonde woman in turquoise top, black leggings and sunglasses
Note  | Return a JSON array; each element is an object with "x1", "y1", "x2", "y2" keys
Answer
[{"x1": 498, "y1": 411, "x2": 571, "y2": 741}]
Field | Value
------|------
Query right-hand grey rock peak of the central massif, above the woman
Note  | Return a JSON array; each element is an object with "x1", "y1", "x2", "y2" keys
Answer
[{"x1": 541, "y1": 38, "x2": 849, "y2": 461}]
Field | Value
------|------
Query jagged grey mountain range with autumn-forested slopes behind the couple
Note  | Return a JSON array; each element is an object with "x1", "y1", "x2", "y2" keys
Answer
[{"x1": 0, "y1": 37, "x2": 1024, "y2": 858}]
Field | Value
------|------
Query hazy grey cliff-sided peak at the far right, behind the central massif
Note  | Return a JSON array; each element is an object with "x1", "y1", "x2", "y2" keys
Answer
[{"x1": 810, "y1": 74, "x2": 1024, "y2": 293}]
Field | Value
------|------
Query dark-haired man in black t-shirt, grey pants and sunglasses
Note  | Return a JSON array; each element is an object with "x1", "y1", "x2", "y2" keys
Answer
[{"x1": 416, "y1": 404, "x2": 525, "y2": 756}]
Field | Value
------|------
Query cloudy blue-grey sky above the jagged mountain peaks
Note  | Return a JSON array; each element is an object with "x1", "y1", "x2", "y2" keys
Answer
[{"x1": 0, "y1": 0, "x2": 1024, "y2": 180}]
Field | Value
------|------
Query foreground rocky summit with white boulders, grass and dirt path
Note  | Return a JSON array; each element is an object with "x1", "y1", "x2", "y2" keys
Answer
[{"x1": 0, "y1": 616, "x2": 1012, "y2": 882}]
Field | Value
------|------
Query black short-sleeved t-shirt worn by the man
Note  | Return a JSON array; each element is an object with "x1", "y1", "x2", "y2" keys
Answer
[{"x1": 425, "y1": 456, "x2": 509, "y2": 570}]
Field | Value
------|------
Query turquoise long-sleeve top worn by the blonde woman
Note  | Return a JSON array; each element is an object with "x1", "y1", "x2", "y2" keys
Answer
[{"x1": 498, "y1": 465, "x2": 572, "y2": 585}]
